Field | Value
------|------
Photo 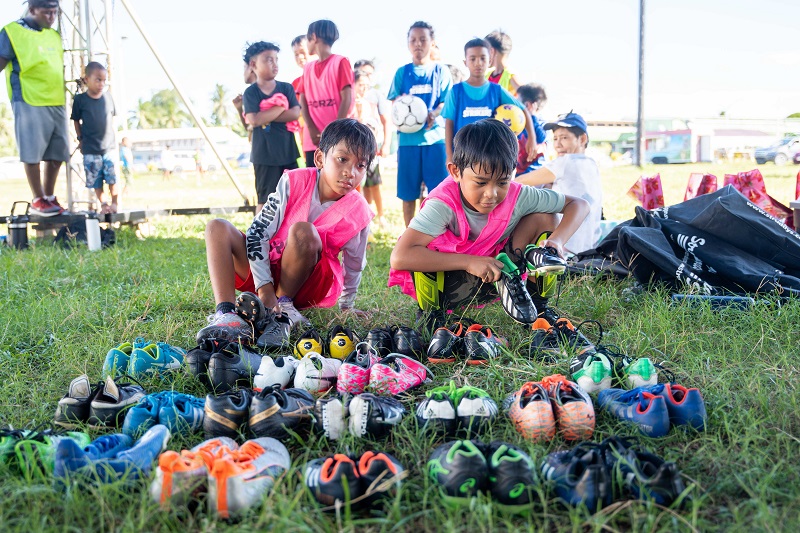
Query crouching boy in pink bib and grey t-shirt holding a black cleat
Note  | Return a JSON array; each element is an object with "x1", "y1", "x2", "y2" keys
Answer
[{"x1": 389, "y1": 119, "x2": 589, "y2": 324}]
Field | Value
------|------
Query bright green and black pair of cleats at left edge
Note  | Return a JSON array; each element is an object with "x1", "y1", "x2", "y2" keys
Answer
[{"x1": 0, "y1": 427, "x2": 92, "y2": 480}]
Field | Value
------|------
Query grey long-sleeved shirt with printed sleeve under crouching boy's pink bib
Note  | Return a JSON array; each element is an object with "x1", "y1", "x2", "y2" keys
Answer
[{"x1": 246, "y1": 171, "x2": 369, "y2": 307}]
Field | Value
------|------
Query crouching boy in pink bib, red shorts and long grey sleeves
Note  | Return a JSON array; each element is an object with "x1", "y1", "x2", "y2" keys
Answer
[{"x1": 197, "y1": 119, "x2": 377, "y2": 343}]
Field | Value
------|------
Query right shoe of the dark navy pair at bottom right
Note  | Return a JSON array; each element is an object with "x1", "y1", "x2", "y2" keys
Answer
[{"x1": 616, "y1": 442, "x2": 686, "y2": 506}]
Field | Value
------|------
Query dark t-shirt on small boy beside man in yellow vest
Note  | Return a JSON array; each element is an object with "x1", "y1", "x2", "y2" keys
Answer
[{"x1": 70, "y1": 93, "x2": 117, "y2": 155}]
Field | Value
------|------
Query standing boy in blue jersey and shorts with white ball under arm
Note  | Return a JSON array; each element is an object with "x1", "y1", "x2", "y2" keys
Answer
[{"x1": 388, "y1": 21, "x2": 453, "y2": 227}]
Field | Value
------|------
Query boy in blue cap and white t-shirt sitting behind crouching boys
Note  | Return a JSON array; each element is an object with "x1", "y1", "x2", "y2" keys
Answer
[{"x1": 516, "y1": 111, "x2": 603, "y2": 254}]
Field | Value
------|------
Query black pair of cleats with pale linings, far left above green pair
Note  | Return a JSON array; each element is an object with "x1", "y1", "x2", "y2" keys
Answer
[{"x1": 54, "y1": 374, "x2": 146, "y2": 429}]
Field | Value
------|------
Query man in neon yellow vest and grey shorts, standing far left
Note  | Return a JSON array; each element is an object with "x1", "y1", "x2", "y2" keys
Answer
[{"x1": 0, "y1": 0, "x2": 69, "y2": 216}]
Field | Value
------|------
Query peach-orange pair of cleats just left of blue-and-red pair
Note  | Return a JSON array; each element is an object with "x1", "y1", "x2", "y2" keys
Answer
[{"x1": 503, "y1": 374, "x2": 595, "y2": 443}]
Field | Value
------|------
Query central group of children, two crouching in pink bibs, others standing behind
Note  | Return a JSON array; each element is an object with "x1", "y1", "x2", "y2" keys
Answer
[{"x1": 198, "y1": 20, "x2": 601, "y2": 341}]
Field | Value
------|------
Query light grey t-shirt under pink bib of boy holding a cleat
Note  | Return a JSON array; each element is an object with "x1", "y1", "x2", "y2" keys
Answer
[{"x1": 408, "y1": 186, "x2": 564, "y2": 241}]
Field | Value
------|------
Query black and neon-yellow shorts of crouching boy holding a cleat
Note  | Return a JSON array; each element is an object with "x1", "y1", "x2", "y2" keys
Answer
[{"x1": 412, "y1": 270, "x2": 498, "y2": 310}]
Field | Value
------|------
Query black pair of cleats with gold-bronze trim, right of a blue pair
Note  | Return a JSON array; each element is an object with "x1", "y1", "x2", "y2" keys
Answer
[{"x1": 203, "y1": 387, "x2": 314, "y2": 440}]
